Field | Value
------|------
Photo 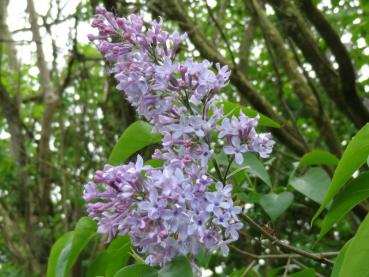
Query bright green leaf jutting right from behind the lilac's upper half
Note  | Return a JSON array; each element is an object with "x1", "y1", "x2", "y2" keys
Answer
[{"x1": 217, "y1": 101, "x2": 281, "y2": 128}]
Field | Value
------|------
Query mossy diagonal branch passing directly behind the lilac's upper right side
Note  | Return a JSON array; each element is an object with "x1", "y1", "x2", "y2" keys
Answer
[{"x1": 149, "y1": 0, "x2": 308, "y2": 155}]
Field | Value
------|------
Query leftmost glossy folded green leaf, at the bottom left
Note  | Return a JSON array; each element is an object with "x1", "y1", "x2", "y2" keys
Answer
[{"x1": 47, "y1": 217, "x2": 97, "y2": 277}]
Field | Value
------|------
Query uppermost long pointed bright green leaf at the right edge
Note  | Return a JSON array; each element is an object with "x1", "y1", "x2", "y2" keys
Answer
[{"x1": 312, "y1": 123, "x2": 369, "y2": 222}]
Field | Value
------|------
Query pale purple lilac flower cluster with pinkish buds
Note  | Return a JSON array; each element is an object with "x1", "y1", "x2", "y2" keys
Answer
[{"x1": 84, "y1": 7, "x2": 274, "y2": 265}]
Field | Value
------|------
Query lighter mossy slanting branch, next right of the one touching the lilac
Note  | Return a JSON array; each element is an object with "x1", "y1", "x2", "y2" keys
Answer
[{"x1": 246, "y1": 0, "x2": 342, "y2": 156}]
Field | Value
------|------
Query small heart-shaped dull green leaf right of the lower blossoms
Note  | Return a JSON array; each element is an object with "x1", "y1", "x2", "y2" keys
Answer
[{"x1": 259, "y1": 191, "x2": 293, "y2": 221}]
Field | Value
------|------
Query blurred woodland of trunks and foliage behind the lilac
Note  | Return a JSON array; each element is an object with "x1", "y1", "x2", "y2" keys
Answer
[{"x1": 0, "y1": 0, "x2": 369, "y2": 276}]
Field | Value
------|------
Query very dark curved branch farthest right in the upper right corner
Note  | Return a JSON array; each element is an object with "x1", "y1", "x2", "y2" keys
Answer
[{"x1": 298, "y1": 0, "x2": 369, "y2": 127}]
